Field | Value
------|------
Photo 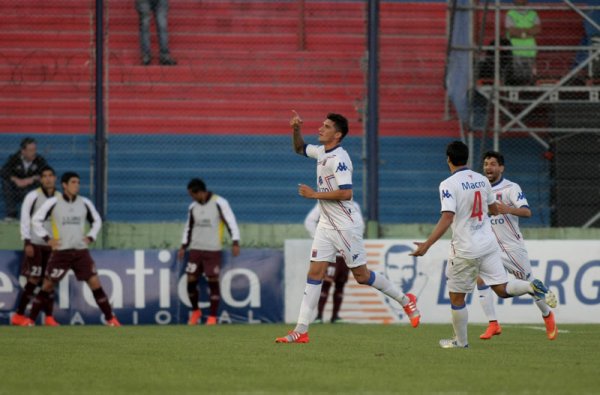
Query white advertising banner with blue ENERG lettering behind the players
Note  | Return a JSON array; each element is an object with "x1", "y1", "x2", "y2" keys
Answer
[{"x1": 284, "y1": 240, "x2": 600, "y2": 323}]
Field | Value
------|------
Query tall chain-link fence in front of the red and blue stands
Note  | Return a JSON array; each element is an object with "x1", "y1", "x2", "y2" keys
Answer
[{"x1": 0, "y1": 0, "x2": 600, "y2": 226}]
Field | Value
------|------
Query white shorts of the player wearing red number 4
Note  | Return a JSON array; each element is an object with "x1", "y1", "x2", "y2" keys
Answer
[{"x1": 446, "y1": 250, "x2": 508, "y2": 293}]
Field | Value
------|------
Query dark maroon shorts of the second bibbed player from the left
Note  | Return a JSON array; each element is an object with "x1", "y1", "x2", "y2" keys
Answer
[{"x1": 46, "y1": 250, "x2": 98, "y2": 282}]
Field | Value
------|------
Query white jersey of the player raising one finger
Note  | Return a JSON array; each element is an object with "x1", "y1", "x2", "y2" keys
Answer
[{"x1": 304, "y1": 144, "x2": 361, "y2": 230}]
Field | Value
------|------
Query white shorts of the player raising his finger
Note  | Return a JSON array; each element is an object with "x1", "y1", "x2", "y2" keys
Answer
[{"x1": 310, "y1": 226, "x2": 367, "y2": 268}]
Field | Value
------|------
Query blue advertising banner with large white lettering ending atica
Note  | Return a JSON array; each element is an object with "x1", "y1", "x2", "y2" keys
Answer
[{"x1": 0, "y1": 249, "x2": 284, "y2": 325}]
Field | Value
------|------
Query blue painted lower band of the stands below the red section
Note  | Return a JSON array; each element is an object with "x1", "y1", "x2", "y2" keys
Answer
[{"x1": 0, "y1": 134, "x2": 551, "y2": 226}]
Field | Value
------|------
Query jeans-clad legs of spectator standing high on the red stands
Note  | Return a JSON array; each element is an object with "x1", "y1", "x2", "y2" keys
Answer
[{"x1": 135, "y1": 0, "x2": 177, "y2": 66}]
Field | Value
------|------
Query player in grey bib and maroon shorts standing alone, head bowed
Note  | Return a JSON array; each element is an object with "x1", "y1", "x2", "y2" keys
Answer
[{"x1": 177, "y1": 178, "x2": 240, "y2": 325}]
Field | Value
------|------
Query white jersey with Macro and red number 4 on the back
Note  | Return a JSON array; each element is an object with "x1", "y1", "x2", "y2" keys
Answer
[{"x1": 440, "y1": 168, "x2": 498, "y2": 259}]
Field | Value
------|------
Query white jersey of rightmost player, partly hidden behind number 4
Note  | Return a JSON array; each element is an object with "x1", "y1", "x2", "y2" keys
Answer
[{"x1": 491, "y1": 178, "x2": 529, "y2": 251}]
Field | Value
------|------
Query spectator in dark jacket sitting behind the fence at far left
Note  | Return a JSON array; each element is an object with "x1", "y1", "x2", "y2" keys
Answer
[{"x1": 1, "y1": 137, "x2": 48, "y2": 221}]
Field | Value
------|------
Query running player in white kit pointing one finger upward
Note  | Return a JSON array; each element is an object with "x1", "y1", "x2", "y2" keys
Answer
[{"x1": 275, "y1": 111, "x2": 420, "y2": 343}]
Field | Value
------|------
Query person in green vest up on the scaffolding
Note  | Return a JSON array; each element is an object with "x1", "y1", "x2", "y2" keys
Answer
[{"x1": 504, "y1": 0, "x2": 542, "y2": 85}]
